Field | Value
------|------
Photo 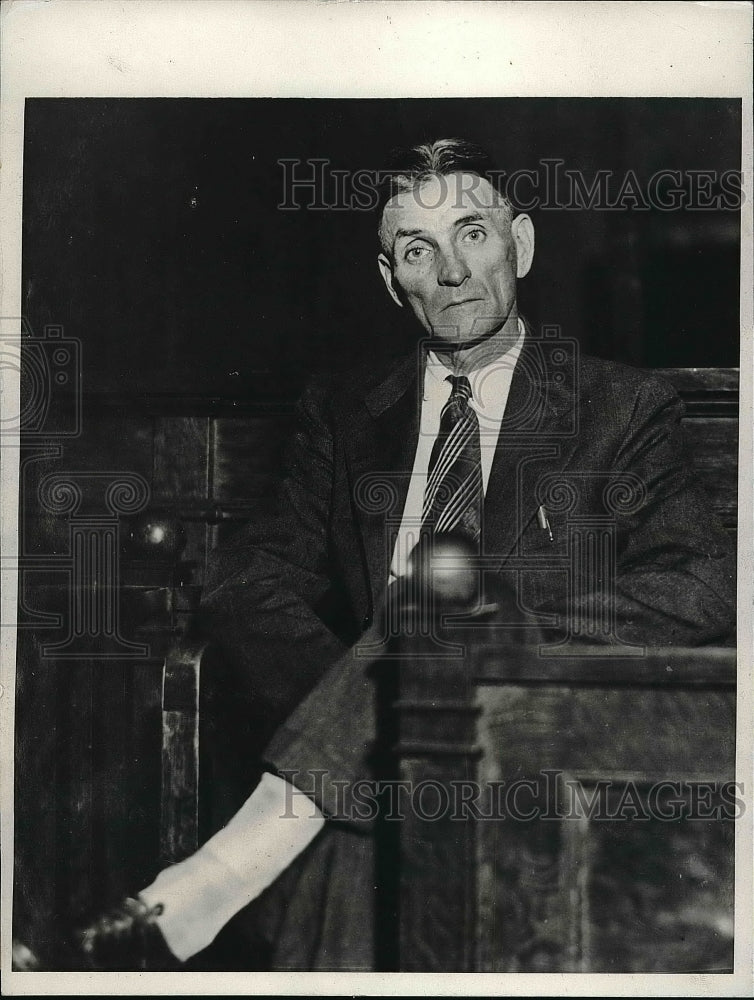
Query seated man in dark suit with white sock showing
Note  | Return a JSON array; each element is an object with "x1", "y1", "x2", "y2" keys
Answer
[{"x1": 78, "y1": 140, "x2": 735, "y2": 970}]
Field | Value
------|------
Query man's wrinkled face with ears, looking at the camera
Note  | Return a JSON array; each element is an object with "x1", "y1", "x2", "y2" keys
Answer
[{"x1": 379, "y1": 173, "x2": 534, "y2": 344}]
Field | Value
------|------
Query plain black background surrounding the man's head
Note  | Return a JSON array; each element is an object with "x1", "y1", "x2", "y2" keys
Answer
[{"x1": 23, "y1": 98, "x2": 741, "y2": 396}]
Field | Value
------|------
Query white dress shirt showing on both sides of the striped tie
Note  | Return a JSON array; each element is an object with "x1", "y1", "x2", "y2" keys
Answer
[{"x1": 389, "y1": 319, "x2": 524, "y2": 583}]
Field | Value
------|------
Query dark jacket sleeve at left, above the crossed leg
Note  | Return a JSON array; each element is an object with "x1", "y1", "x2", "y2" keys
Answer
[{"x1": 201, "y1": 383, "x2": 347, "y2": 730}]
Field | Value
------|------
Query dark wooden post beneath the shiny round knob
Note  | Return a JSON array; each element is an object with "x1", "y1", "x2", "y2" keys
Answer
[{"x1": 378, "y1": 638, "x2": 477, "y2": 972}]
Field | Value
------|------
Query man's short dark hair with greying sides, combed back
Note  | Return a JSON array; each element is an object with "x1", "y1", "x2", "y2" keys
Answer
[{"x1": 378, "y1": 139, "x2": 515, "y2": 258}]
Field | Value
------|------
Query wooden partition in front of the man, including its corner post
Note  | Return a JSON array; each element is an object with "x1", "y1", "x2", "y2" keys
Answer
[{"x1": 388, "y1": 635, "x2": 735, "y2": 972}]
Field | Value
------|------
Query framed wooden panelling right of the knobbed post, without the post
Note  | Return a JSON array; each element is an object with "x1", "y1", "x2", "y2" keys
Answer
[{"x1": 477, "y1": 672, "x2": 735, "y2": 972}]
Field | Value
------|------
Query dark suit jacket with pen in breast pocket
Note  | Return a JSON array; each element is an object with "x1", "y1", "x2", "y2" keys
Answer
[{"x1": 203, "y1": 335, "x2": 735, "y2": 800}]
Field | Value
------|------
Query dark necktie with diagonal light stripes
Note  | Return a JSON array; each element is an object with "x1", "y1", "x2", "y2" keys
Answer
[{"x1": 422, "y1": 375, "x2": 484, "y2": 542}]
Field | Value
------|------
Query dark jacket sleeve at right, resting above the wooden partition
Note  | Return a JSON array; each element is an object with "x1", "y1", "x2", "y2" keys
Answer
[{"x1": 543, "y1": 378, "x2": 736, "y2": 646}]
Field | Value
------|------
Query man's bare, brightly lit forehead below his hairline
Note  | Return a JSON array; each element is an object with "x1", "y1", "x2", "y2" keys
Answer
[{"x1": 384, "y1": 173, "x2": 505, "y2": 236}]
